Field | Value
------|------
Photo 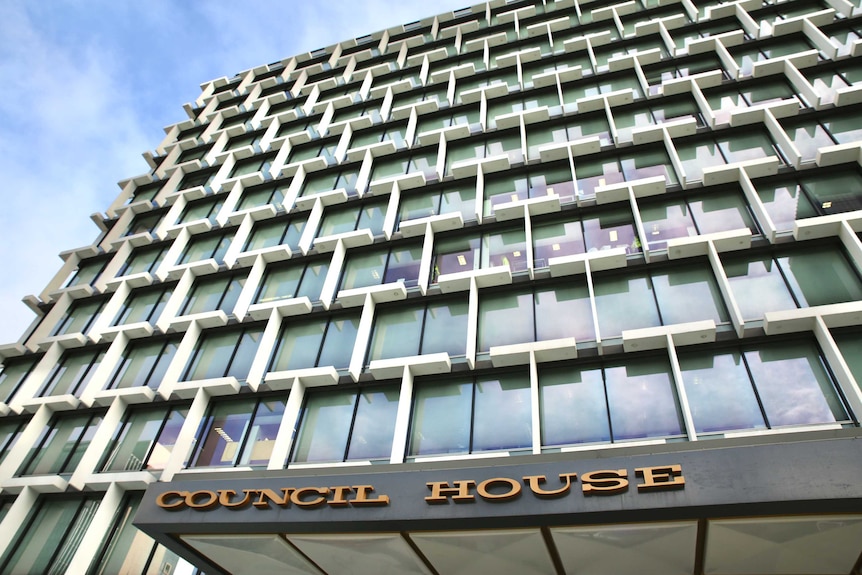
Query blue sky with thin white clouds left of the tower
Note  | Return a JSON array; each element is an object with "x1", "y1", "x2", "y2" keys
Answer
[{"x1": 0, "y1": 0, "x2": 470, "y2": 344}]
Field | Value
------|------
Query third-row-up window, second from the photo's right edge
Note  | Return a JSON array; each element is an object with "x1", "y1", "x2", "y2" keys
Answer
[{"x1": 638, "y1": 185, "x2": 758, "y2": 250}]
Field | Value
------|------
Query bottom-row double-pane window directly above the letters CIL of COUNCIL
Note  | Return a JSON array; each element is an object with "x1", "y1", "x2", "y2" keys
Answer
[{"x1": 290, "y1": 385, "x2": 400, "y2": 463}]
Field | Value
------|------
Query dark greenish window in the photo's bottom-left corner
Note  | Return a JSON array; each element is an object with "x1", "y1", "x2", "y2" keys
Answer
[{"x1": 0, "y1": 495, "x2": 99, "y2": 573}]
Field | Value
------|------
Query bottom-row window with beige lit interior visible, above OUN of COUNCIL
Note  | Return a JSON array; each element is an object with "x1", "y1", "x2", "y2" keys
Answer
[{"x1": 190, "y1": 397, "x2": 285, "y2": 467}]
